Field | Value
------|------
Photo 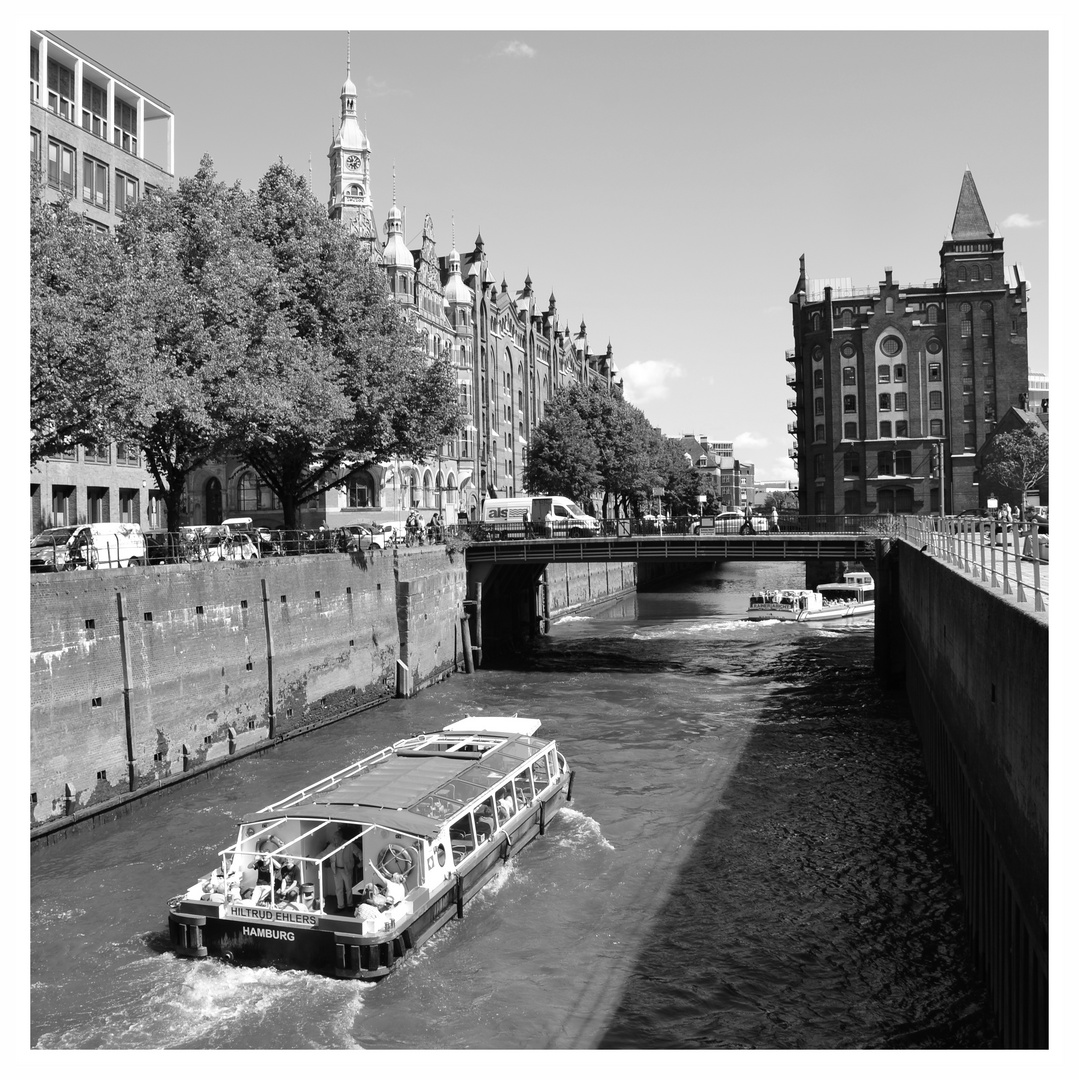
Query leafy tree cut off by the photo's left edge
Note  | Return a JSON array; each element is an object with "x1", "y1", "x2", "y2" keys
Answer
[{"x1": 30, "y1": 168, "x2": 146, "y2": 463}]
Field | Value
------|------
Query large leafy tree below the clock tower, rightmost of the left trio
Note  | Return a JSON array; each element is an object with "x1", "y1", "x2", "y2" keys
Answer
[{"x1": 230, "y1": 162, "x2": 460, "y2": 527}]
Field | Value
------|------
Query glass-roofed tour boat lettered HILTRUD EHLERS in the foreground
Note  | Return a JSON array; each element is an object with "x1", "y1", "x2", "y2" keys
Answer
[{"x1": 168, "y1": 716, "x2": 574, "y2": 980}]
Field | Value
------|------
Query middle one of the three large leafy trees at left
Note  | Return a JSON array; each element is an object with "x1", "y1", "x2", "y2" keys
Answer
[{"x1": 117, "y1": 157, "x2": 272, "y2": 531}]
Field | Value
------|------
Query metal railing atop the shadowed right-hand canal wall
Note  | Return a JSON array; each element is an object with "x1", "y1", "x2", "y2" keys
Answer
[{"x1": 898, "y1": 514, "x2": 1049, "y2": 611}]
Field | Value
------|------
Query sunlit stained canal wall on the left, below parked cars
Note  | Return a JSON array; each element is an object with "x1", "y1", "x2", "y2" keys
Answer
[{"x1": 30, "y1": 549, "x2": 466, "y2": 836}]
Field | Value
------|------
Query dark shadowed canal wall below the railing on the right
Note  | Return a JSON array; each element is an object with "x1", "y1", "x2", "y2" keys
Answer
[{"x1": 877, "y1": 542, "x2": 1049, "y2": 1047}]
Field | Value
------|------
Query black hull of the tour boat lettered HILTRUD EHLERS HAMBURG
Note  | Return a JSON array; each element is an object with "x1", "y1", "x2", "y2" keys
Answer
[{"x1": 168, "y1": 770, "x2": 574, "y2": 980}]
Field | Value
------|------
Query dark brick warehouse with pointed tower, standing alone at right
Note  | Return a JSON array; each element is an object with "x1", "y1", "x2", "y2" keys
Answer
[{"x1": 786, "y1": 171, "x2": 1028, "y2": 514}]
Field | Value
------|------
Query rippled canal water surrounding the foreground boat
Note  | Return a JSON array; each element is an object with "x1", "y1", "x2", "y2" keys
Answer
[{"x1": 30, "y1": 564, "x2": 996, "y2": 1049}]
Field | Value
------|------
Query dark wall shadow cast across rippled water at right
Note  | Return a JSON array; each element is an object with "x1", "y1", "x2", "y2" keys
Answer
[{"x1": 598, "y1": 635, "x2": 997, "y2": 1049}]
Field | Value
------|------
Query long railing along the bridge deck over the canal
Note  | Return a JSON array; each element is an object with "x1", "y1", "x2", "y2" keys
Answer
[{"x1": 446, "y1": 513, "x2": 898, "y2": 543}]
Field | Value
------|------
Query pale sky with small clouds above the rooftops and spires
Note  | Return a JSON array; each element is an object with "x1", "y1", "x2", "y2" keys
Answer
[{"x1": 35, "y1": 16, "x2": 1053, "y2": 481}]
